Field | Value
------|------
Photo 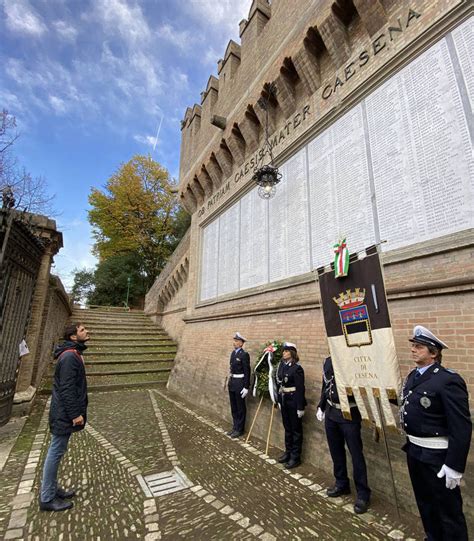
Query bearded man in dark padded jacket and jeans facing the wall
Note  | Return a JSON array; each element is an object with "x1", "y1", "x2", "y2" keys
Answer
[{"x1": 40, "y1": 323, "x2": 89, "y2": 511}]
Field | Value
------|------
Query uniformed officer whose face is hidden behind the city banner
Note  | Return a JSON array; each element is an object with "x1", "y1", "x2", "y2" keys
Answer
[{"x1": 316, "y1": 357, "x2": 371, "y2": 514}]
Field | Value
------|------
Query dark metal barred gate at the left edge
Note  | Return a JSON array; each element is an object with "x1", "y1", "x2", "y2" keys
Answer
[{"x1": 0, "y1": 209, "x2": 44, "y2": 426}]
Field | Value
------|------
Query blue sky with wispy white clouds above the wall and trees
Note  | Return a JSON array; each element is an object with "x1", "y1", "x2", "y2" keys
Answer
[{"x1": 0, "y1": 0, "x2": 251, "y2": 287}]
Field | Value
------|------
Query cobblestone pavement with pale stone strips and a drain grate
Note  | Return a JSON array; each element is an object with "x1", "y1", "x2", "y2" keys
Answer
[{"x1": 0, "y1": 389, "x2": 422, "y2": 541}]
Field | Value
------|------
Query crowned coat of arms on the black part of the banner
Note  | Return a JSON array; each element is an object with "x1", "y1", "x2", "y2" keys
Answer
[{"x1": 333, "y1": 287, "x2": 372, "y2": 347}]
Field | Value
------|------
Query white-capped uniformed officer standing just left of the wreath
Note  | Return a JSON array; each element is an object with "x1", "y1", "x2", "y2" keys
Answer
[{"x1": 227, "y1": 332, "x2": 250, "y2": 438}]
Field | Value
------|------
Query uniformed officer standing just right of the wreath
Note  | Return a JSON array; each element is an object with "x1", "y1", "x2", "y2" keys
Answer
[{"x1": 276, "y1": 342, "x2": 306, "y2": 470}]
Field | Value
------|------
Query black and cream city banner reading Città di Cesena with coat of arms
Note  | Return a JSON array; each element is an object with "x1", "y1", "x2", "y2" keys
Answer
[{"x1": 318, "y1": 247, "x2": 401, "y2": 426}]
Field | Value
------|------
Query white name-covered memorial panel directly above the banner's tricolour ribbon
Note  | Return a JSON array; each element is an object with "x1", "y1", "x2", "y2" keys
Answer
[{"x1": 308, "y1": 105, "x2": 375, "y2": 268}]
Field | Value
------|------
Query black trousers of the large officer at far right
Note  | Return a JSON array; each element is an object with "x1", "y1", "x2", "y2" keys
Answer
[{"x1": 407, "y1": 454, "x2": 468, "y2": 541}]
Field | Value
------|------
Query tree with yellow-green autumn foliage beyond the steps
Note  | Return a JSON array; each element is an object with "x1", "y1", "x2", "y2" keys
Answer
[{"x1": 89, "y1": 155, "x2": 189, "y2": 289}]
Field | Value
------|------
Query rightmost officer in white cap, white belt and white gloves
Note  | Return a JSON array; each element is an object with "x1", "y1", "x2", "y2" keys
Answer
[{"x1": 400, "y1": 325, "x2": 472, "y2": 541}]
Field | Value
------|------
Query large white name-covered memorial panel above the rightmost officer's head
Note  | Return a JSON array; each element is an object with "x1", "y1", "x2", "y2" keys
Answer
[{"x1": 366, "y1": 36, "x2": 473, "y2": 250}]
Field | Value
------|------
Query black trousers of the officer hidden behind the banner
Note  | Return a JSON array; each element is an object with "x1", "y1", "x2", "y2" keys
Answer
[{"x1": 325, "y1": 412, "x2": 371, "y2": 501}]
